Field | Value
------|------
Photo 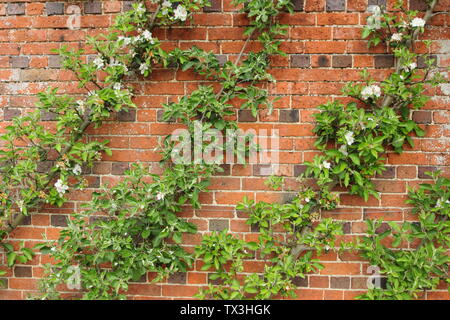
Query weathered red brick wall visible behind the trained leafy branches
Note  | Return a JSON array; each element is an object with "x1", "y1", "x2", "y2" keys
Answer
[{"x1": 0, "y1": 0, "x2": 450, "y2": 299}]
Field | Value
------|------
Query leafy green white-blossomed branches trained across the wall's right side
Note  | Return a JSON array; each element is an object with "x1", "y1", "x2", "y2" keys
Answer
[{"x1": 197, "y1": 1, "x2": 449, "y2": 299}]
